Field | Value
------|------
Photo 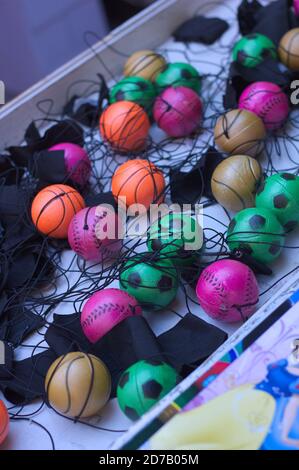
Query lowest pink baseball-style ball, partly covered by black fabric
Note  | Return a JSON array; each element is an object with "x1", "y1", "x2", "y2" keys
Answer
[{"x1": 81, "y1": 289, "x2": 142, "y2": 343}]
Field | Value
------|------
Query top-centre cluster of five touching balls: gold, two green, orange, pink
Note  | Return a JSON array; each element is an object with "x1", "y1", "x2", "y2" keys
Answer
[{"x1": 100, "y1": 50, "x2": 202, "y2": 153}]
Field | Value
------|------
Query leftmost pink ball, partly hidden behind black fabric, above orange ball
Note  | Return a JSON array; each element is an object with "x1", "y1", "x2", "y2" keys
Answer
[{"x1": 49, "y1": 142, "x2": 91, "y2": 186}]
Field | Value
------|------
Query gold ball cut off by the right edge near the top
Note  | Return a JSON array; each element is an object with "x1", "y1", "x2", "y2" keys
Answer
[{"x1": 278, "y1": 28, "x2": 299, "y2": 72}]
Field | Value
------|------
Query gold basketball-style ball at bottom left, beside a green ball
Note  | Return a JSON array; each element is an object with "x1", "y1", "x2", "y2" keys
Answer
[{"x1": 45, "y1": 352, "x2": 111, "y2": 419}]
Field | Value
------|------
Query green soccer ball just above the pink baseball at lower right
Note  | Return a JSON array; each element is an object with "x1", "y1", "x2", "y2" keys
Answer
[{"x1": 227, "y1": 207, "x2": 285, "y2": 264}]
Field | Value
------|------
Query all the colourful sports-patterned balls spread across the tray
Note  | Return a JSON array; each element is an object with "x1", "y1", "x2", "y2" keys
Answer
[{"x1": 18, "y1": 29, "x2": 299, "y2": 432}]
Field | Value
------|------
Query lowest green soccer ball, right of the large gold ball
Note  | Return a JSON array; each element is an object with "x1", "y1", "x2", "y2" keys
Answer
[{"x1": 117, "y1": 359, "x2": 180, "y2": 421}]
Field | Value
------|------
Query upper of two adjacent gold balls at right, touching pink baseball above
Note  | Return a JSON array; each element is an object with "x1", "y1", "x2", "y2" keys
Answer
[{"x1": 214, "y1": 109, "x2": 267, "y2": 157}]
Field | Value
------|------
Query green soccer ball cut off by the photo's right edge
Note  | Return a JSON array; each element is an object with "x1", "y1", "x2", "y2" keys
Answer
[{"x1": 256, "y1": 173, "x2": 299, "y2": 232}]
